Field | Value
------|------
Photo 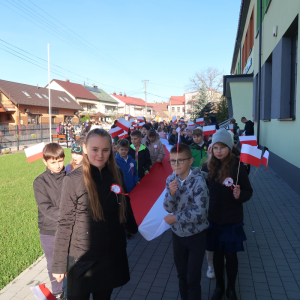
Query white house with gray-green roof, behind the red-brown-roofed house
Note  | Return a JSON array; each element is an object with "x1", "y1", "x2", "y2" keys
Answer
[{"x1": 84, "y1": 85, "x2": 119, "y2": 121}]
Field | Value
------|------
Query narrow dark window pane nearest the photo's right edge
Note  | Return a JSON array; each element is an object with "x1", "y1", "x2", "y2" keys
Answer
[{"x1": 290, "y1": 32, "x2": 298, "y2": 119}]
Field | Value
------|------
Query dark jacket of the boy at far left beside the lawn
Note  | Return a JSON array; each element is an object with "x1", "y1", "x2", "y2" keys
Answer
[{"x1": 33, "y1": 169, "x2": 66, "y2": 235}]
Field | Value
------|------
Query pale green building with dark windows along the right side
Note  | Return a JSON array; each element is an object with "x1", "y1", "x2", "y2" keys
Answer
[{"x1": 223, "y1": 0, "x2": 300, "y2": 194}]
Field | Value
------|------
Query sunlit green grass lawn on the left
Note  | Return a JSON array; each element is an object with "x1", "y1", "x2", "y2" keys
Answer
[{"x1": 0, "y1": 149, "x2": 71, "y2": 290}]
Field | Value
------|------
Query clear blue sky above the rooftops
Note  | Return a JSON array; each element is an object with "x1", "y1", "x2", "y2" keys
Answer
[{"x1": 0, "y1": 0, "x2": 241, "y2": 102}]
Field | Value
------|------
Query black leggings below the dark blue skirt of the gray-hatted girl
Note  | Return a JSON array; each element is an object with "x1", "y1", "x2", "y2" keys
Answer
[{"x1": 214, "y1": 251, "x2": 239, "y2": 289}]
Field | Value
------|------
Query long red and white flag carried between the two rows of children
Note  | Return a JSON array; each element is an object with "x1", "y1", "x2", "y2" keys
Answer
[{"x1": 129, "y1": 139, "x2": 173, "y2": 241}]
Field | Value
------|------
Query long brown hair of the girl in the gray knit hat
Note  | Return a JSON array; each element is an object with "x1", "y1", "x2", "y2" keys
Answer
[{"x1": 207, "y1": 143, "x2": 236, "y2": 183}]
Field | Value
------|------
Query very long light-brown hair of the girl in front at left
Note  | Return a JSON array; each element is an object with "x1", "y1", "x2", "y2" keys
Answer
[{"x1": 82, "y1": 129, "x2": 126, "y2": 223}]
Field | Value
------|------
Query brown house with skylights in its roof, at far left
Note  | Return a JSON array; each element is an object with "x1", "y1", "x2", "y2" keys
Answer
[{"x1": 0, "y1": 80, "x2": 81, "y2": 125}]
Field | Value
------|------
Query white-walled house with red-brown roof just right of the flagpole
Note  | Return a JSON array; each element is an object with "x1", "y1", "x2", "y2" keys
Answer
[{"x1": 47, "y1": 79, "x2": 101, "y2": 118}]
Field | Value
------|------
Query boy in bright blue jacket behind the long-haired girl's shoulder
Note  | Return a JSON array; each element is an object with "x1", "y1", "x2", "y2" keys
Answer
[{"x1": 115, "y1": 139, "x2": 139, "y2": 193}]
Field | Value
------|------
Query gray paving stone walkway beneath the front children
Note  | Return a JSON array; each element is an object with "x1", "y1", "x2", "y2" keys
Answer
[{"x1": 0, "y1": 168, "x2": 300, "y2": 300}]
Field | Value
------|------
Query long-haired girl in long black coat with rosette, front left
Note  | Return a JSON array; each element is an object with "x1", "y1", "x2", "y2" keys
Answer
[{"x1": 52, "y1": 129, "x2": 138, "y2": 300}]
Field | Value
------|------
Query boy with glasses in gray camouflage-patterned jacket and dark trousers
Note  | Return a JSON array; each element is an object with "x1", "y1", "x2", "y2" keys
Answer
[{"x1": 164, "y1": 144, "x2": 209, "y2": 300}]
